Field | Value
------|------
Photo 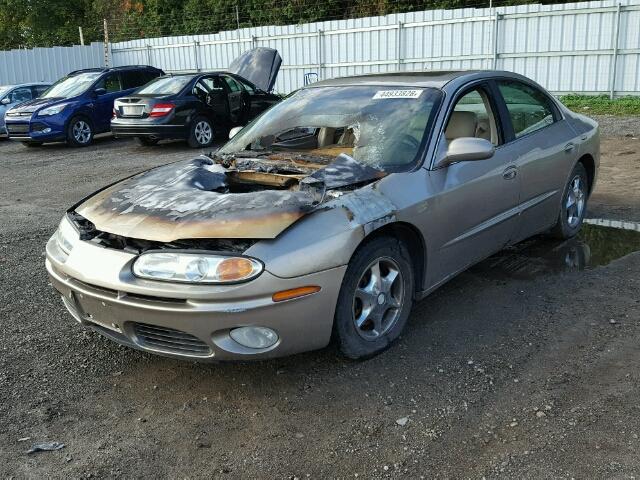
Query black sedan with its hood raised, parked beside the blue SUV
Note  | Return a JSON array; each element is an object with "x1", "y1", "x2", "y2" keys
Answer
[{"x1": 111, "y1": 48, "x2": 282, "y2": 148}]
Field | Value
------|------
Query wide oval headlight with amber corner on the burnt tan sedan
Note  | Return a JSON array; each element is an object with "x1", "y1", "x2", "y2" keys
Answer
[{"x1": 133, "y1": 252, "x2": 262, "y2": 283}]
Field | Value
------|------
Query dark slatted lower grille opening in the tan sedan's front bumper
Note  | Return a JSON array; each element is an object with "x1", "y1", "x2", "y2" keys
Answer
[{"x1": 133, "y1": 323, "x2": 211, "y2": 357}]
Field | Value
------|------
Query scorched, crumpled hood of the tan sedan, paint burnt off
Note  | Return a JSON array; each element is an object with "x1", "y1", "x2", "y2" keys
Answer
[{"x1": 75, "y1": 154, "x2": 386, "y2": 242}]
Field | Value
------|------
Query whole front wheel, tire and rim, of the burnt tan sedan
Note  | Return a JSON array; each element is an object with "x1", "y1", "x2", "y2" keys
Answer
[{"x1": 334, "y1": 237, "x2": 414, "y2": 359}]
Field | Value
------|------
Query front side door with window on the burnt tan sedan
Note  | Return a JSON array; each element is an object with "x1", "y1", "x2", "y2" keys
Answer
[{"x1": 425, "y1": 83, "x2": 520, "y2": 283}]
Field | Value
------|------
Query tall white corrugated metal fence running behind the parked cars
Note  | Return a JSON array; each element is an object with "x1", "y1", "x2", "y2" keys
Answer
[{"x1": 0, "y1": 0, "x2": 640, "y2": 96}]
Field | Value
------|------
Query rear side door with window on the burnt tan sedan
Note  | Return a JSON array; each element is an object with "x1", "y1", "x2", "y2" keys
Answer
[{"x1": 496, "y1": 79, "x2": 578, "y2": 242}]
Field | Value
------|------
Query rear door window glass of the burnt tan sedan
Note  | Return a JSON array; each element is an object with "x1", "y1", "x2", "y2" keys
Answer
[{"x1": 498, "y1": 81, "x2": 555, "y2": 138}]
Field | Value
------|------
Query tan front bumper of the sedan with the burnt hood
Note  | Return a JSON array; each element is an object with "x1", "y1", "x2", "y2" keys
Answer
[{"x1": 46, "y1": 234, "x2": 346, "y2": 361}]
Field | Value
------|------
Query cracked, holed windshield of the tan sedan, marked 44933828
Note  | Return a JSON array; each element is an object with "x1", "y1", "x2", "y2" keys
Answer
[{"x1": 217, "y1": 86, "x2": 440, "y2": 170}]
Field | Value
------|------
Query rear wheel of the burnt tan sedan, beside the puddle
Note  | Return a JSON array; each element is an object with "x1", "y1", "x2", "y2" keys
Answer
[{"x1": 551, "y1": 163, "x2": 589, "y2": 240}]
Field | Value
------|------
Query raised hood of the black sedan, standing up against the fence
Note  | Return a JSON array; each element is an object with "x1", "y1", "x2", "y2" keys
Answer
[{"x1": 228, "y1": 47, "x2": 282, "y2": 92}]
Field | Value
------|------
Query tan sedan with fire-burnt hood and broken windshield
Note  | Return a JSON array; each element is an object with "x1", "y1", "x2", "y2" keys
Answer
[{"x1": 46, "y1": 71, "x2": 599, "y2": 360}]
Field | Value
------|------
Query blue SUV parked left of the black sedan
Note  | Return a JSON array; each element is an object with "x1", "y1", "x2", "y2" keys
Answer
[{"x1": 5, "y1": 65, "x2": 164, "y2": 147}]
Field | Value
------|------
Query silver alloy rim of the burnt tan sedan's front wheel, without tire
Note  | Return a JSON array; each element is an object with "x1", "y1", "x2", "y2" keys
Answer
[{"x1": 353, "y1": 257, "x2": 404, "y2": 341}]
